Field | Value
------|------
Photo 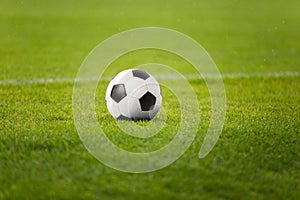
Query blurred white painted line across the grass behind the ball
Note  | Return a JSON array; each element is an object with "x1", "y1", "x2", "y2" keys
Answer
[{"x1": 0, "y1": 72, "x2": 300, "y2": 85}]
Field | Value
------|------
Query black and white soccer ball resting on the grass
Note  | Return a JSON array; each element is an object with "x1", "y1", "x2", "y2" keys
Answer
[{"x1": 105, "y1": 69, "x2": 162, "y2": 121}]
